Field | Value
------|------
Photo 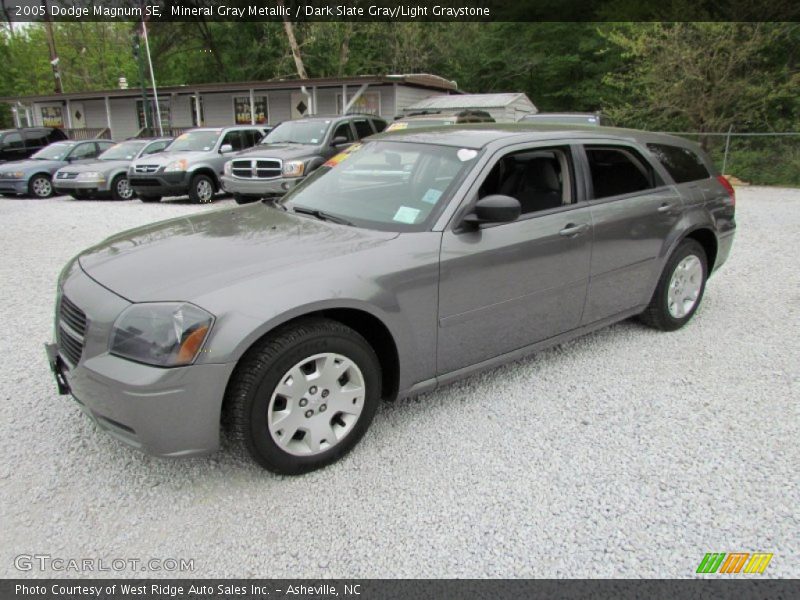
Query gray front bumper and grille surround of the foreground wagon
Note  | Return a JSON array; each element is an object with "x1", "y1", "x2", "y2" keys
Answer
[{"x1": 46, "y1": 270, "x2": 234, "y2": 457}]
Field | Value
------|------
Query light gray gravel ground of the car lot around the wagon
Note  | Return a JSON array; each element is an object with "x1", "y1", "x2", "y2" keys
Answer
[{"x1": 0, "y1": 187, "x2": 800, "y2": 577}]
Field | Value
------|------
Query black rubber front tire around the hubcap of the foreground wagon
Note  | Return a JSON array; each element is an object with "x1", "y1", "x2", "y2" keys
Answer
[{"x1": 225, "y1": 318, "x2": 381, "y2": 475}]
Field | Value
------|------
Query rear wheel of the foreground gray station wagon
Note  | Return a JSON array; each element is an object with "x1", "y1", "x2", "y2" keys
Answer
[{"x1": 640, "y1": 239, "x2": 708, "y2": 331}]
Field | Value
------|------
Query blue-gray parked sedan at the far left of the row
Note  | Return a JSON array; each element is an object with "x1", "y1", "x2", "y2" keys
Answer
[{"x1": 0, "y1": 140, "x2": 114, "y2": 198}]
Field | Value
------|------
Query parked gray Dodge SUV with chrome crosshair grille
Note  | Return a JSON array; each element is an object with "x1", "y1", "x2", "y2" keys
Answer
[{"x1": 222, "y1": 114, "x2": 386, "y2": 204}]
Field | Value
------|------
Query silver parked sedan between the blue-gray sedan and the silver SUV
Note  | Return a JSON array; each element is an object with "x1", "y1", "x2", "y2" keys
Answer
[{"x1": 53, "y1": 138, "x2": 172, "y2": 200}]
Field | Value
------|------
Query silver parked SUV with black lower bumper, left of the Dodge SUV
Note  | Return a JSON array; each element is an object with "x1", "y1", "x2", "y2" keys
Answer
[{"x1": 128, "y1": 127, "x2": 264, "y2": 202}]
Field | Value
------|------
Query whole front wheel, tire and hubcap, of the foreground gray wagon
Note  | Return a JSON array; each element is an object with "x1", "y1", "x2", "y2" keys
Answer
[{"x1": 226, "y1": 319, "x2": 381, "y2": 475}]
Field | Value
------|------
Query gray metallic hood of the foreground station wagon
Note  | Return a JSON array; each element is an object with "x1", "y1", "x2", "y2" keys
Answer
[{"x1": 79, "y1": 202, "x2": 398, "y2": 302}]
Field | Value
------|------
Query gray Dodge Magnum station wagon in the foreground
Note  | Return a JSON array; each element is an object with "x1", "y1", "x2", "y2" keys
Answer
[{"x1": 47, "y1": 124, "x2": 735, "y2": 474}]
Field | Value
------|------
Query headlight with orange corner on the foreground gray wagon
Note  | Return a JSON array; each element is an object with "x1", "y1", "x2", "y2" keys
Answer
[{"x1": 110, "y1": 302, "x2": 214, "y2": 367}]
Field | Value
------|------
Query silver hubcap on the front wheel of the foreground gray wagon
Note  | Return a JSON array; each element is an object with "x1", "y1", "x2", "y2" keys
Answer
[{"x1": 267, "y1": 352, "x2": 366, "y2": 456}]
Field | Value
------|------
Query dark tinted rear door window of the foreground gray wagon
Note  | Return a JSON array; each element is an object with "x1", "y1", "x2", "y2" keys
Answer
[{"x1": 585, "y1": 146, "x2": 661, "y2": 198}]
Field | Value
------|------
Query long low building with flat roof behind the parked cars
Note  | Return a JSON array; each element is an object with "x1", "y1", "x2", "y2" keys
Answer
[{"x1": 0, "y1": 73, "x2": 460, "y2": 140}]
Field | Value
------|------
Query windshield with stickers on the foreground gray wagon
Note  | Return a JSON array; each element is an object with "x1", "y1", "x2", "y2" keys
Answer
[{"x1": 283, "y1": 140, "x2": 478, "y2": 231}]
